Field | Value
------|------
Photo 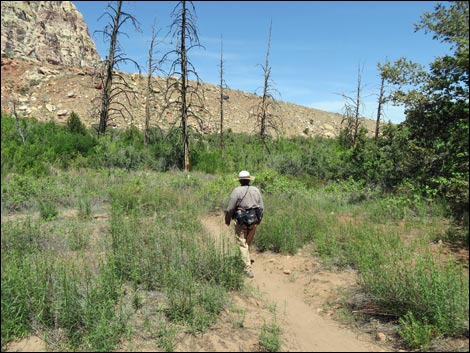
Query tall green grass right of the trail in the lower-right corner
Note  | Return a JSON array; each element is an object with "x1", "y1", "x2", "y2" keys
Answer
[{"x1": 348, "y1": 221, "x2": 469, "y2": 345}]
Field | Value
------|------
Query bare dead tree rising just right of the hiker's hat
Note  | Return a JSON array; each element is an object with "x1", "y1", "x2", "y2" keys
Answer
[{"x1": 249, "y1": 23, "x2": 281, "y2": 147}]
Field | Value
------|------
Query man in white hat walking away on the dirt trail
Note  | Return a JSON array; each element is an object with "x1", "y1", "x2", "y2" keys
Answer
[{"x1": 225, "y1": 170, "x2": 264, "y2": 278}]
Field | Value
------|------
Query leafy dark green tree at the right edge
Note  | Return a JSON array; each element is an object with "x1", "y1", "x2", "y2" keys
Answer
[{"x1": 379, "y1": 1, "x2": 470, "y2": 220}]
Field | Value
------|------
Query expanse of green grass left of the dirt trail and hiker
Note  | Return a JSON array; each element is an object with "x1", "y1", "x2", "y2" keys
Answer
[{"x1": 2, "y1": 170, "x2": 248, "y2": 351}]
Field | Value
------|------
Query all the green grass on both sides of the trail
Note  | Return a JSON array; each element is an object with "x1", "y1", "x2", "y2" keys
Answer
[{"x1": 1, "y1": 128, "x2": 469, "y2": 351}]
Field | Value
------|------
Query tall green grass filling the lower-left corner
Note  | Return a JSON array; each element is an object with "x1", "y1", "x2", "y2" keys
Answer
[{"x1": 2, "y1": 214, "x2": 125, "y2": 351}]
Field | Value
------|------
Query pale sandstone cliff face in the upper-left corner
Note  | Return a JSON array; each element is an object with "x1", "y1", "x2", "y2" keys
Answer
[{"x1": 1, "y1": 1, "x2": 101, "y2": 67}]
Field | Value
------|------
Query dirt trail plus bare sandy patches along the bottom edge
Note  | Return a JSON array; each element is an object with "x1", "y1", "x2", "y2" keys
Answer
[{"x1": 7, "y1": 214, "x2": 393, "y2": 352}]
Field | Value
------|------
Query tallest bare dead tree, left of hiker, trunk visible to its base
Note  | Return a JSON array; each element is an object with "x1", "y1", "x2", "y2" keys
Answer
[{"x1": 162, "y1": 1, "x2": 207, "y2": 172}]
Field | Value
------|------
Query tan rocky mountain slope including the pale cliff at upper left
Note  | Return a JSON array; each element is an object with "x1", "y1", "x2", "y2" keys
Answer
[{"x1": 1, "y1": 1, "x2": 375, "y2": 137}]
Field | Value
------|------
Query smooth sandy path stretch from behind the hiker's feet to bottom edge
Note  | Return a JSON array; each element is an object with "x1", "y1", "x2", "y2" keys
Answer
[{"x1": 252, "y1": 254, "x2": 385, "y2": 352}]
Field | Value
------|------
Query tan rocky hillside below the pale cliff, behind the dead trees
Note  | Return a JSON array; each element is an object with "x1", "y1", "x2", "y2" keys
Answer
[{"x1": 1, "y1": 57, "x2": 375, "y2": 137}]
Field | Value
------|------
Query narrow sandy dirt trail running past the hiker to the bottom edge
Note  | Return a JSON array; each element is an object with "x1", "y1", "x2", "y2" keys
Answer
[{"x1": 193, "y1": 215, "x2": 391, "y2": 352}]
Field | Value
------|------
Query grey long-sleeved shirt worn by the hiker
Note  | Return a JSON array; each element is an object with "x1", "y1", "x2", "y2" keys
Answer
[{"x1": 225, "y1": 185, "x2": 264, "y2": 224}]
